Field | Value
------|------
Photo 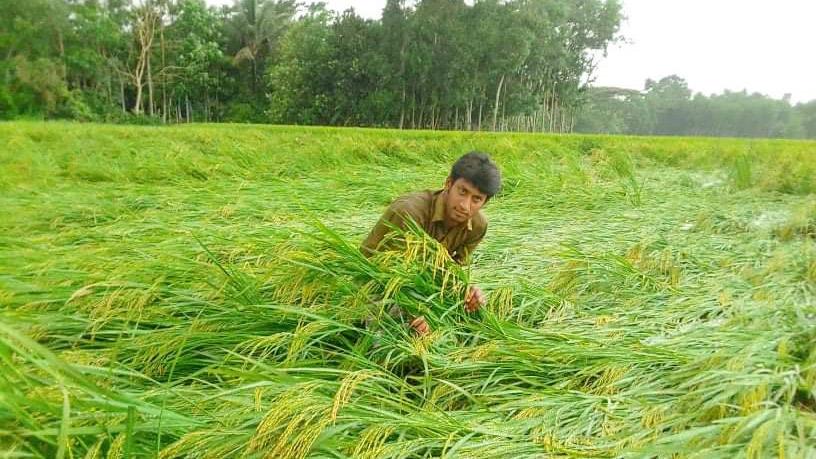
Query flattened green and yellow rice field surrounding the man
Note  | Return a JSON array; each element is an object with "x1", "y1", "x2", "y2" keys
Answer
[{"x1": 0, "y1": 122, "x2": 816, "y2": 458}]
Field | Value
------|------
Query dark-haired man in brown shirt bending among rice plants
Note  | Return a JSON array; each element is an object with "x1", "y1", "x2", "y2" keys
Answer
[{"x1": 360, "y1": 151, "x2": 501, "y2": 335}]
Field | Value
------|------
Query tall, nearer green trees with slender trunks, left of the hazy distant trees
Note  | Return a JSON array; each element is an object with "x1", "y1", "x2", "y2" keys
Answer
[{"x1": 0, "y1": 0, "x2": 621, "y2": 132}]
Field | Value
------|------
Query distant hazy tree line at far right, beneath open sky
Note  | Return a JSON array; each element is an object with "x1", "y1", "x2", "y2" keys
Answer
[{"x1": 576, "y1": 75, "x2": 816, "y2": 139}]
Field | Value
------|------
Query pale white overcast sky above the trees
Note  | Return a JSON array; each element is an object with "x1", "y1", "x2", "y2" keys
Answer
[{"x1": 209, "y1": 0, "x2": 816, "y2": 102}]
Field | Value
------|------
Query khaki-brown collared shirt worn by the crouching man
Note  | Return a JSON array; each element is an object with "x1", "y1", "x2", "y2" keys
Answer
[{"x1": 360, "y1": 190, "x2": 487, "y2": 264}]
